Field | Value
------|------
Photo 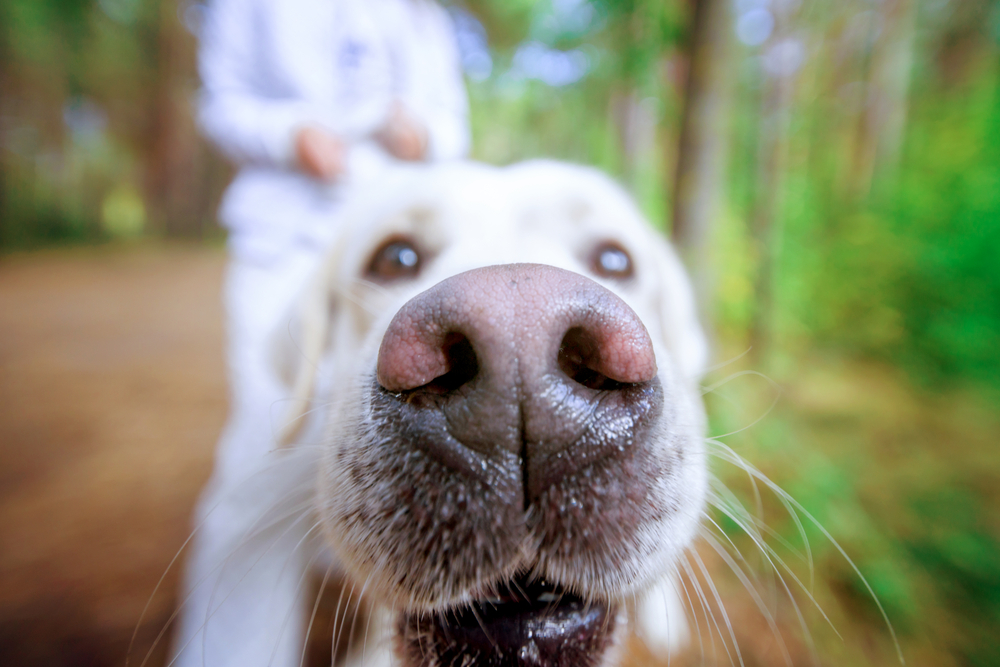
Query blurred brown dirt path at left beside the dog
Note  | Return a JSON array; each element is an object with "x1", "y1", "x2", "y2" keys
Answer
[{"x1": 0, "y1": 247, "x2": 226, "y2": 666}]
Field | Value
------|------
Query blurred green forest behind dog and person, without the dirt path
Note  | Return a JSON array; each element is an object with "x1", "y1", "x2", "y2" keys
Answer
[{"x1": 0, "y1": 0, "x2": 1000, "y2": 666}]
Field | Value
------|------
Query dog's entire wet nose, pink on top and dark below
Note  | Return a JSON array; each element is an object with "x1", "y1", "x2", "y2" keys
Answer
[{"x1": 377, "y1": 264, "x2": 662, "y2": 500}]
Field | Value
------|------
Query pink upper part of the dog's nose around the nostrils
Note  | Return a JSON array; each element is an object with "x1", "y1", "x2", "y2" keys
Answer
[{"x1": 378, "y1": 264, "x2": 656, "y2": 392}]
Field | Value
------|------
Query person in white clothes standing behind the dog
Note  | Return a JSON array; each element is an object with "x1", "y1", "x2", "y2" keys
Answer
[{"x1": 174, "y1": 0, "x2": 470, "y2": 667}]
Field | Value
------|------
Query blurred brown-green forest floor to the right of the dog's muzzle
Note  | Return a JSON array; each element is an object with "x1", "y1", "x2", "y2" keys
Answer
[{"x1": 706, "y1": 362, "x2": 1000, "y2": 665}]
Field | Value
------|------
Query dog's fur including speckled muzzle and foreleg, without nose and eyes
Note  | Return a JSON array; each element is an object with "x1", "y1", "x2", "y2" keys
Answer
[{"x1": 179, "y1": 162, "x2": 707, "y2": 667}]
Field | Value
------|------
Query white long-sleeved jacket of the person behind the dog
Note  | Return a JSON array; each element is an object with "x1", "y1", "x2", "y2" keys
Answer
[{"x1": 199, "y1": 0, "x2": 469, "y2": 261}]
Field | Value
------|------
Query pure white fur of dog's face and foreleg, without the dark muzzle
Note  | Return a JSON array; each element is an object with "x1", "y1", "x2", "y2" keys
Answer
[{"x1": 173, "y1": 162, "x2": 707, "y2": 667}]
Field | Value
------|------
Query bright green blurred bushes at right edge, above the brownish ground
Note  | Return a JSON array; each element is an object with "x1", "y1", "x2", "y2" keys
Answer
[{"x1": 776, "y1": 44, "x2": 1000, "y2": 384}]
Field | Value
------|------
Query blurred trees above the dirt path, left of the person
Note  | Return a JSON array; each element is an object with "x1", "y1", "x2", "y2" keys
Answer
[{"x1": 0, "y1": 0, "x2": 225, "y2": 248}]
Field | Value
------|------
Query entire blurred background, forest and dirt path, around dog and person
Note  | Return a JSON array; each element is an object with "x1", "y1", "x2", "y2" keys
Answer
[{"x1": 0, "y1": 0, "x2": 1000, "y2": 667}]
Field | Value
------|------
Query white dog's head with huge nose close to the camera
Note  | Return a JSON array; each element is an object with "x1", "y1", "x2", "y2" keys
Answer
[{"x1": 278, "y1": 162, "x2": 706, "y2": 667}]
